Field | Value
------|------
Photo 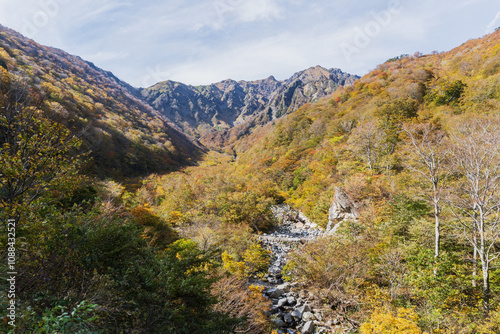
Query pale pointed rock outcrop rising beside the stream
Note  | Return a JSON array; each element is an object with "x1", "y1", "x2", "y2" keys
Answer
[{"x1": 326, "y1": 187, "x2": 358, "y2": 234}]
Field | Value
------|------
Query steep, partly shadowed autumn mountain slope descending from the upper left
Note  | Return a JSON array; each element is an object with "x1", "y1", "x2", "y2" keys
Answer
[{"x1": 0, "y1": 25, "x2": 204, "y2": 176}]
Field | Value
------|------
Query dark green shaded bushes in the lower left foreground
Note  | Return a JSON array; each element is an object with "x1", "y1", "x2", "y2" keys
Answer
[{"x1": 0, "y1": 205, "x2": 238, "y2": 334}]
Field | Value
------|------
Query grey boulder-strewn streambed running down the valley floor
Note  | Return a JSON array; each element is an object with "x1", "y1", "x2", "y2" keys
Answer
[{"x1": 256, "y1": 205, "x2": 335, "y2": 334}]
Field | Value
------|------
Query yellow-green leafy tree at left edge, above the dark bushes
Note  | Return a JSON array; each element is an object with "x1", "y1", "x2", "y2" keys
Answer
[{"x1": 0, "y1": 75, "x2": 81, "y2": 214}]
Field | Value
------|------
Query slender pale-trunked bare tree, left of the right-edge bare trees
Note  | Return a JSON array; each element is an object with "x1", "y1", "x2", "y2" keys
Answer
[{"x1": 403, "y1": 123, "x2": 447, "y2": 275}]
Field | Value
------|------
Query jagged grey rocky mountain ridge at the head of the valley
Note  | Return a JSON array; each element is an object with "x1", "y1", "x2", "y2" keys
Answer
[{"x1": 141, "y1": 66, "x2": 359, "y2": 144}]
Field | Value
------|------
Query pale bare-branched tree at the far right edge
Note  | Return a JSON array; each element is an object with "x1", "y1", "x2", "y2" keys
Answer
[{"x1": 450, "y1": 118, "x2": 500, "y2": 312}]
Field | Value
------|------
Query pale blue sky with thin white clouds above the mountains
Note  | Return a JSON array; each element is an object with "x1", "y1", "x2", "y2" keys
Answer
[{"x1": 0, "y1": 0, "x2": 500, "y2": 87}]
